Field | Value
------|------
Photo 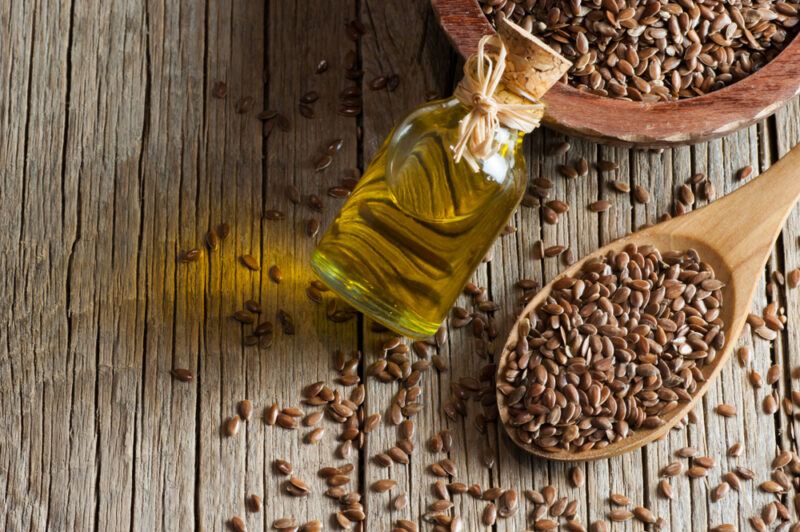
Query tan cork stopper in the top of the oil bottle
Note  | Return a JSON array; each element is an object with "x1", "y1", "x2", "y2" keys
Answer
[{"x1": 497, "y1": 17, "x2": 572, "y2": 99}]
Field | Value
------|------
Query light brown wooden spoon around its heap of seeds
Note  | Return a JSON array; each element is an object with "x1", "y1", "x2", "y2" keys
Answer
[{"x1": 497, "y1": 145, "x2": 800, "y2": 460}]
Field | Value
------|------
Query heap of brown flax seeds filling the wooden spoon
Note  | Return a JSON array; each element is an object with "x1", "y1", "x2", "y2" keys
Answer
[{"x1": 498, "y1": 244, "x2": 725, "y2": 452}]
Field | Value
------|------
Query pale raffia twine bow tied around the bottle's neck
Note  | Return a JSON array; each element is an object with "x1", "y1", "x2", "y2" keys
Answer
[{"x1": 452, "y1": 35, "x2": 544, "y2": 170}]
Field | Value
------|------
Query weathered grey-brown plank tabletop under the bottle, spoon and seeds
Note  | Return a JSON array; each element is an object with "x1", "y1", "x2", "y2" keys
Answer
[{"x1": 0, "y1": 0, "x2": 800, "y2": 531}]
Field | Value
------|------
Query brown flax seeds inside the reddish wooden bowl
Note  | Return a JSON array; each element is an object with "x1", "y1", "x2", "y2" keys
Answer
[{"x1": 479, "y1": 0, "x2": 798, "y2": 102}]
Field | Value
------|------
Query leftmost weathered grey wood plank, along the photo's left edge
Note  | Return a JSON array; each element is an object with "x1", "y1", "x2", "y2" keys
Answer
[{"x1": 0, "y1": 2, "x2": 85, "y2": 530}]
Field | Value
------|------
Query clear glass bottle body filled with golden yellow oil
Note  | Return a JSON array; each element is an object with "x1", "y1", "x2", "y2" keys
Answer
[{"x1": 312, "y1": 99, "x2": 526, "y2": 338}]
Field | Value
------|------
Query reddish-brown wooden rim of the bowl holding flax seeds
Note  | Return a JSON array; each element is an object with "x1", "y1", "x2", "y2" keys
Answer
[{"x1": 431, "y1": 0, "x2": 800, "y2": 148}]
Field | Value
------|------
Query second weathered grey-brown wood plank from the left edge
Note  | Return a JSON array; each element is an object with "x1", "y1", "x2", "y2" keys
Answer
[{"x1": 66, "y1": 2, "x2": 148, "y2": 530}]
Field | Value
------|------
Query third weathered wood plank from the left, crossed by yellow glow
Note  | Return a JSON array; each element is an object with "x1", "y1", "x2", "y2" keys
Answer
[{"x1": 126, "y1": 0, "x2": 206, "y2": 530}]
